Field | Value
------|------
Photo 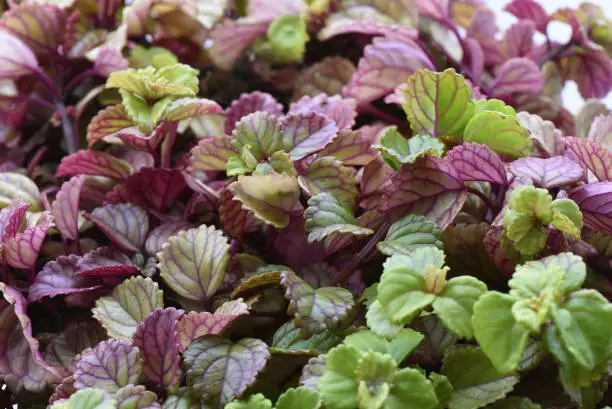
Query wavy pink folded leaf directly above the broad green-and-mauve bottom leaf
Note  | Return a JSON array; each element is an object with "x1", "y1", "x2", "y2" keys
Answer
[{"x1": 177, "y1": 298, "x2": 249, "y2": 350}]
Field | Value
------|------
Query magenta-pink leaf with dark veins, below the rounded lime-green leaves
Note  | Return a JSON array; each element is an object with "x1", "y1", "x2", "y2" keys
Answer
[{"x1": 446, "y1": 143, "x2": 508, "y2": 186}]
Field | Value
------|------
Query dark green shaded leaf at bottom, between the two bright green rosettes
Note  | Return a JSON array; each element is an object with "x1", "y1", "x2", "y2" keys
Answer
[{"x1": 440, "y1": 347, "x2": 519, "y2": 409}]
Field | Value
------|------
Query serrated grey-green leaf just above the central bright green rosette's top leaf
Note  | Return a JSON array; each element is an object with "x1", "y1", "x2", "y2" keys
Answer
[{"x1": 376, "y1": 214, "x2": 444, "y2": 256}]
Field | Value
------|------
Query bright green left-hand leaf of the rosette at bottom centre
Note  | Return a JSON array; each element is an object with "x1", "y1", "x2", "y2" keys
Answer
[{"x1": 317, "y1": 345, "x2": 362, "y2": 409}]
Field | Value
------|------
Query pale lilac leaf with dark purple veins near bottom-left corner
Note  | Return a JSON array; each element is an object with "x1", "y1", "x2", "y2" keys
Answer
[{"x1": 74, "y1": 339, "x2": 143, "y2": 393}]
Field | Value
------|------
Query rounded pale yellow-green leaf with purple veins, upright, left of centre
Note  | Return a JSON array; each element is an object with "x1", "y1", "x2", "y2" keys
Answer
[{"x1": 157, "y1": 225, "x2": 230, "y2": 301}]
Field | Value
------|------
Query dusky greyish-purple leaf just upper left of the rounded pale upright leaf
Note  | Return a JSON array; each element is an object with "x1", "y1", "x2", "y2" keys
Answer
[{"x1": 86, "y1": 203, "x2": 149, "y2": 252}]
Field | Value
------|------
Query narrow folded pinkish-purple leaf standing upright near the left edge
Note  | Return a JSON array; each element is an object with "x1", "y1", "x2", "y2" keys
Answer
[{"x1": 52, "y1": 175, "x2": 85, "y2": 240}]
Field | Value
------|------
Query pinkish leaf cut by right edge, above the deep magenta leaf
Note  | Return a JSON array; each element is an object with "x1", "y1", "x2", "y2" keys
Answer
[{"x1": 564, "y1": 137, "x2": 612, "y2": 182}]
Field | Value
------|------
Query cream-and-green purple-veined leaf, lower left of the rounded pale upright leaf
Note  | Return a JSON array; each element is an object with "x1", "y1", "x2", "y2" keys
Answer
[{"x1": 92, "y1": 276, "x2": 164, "y2": 341}]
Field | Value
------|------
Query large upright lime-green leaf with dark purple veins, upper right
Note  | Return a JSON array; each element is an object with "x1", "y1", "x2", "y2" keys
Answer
[{"x1": 402, "y1": 68, "x2": 474, "y2": 137}]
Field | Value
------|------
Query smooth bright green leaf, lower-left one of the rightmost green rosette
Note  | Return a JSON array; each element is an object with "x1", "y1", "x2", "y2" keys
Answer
[{"x1": 472, "y1": 291, "x2": 529, "y2": 373}]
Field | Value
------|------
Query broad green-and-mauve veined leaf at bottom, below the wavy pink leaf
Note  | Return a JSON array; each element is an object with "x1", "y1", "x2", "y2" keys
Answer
[{"x1": 183, "y1": 337, "x2": 270, "y2": 408}]
